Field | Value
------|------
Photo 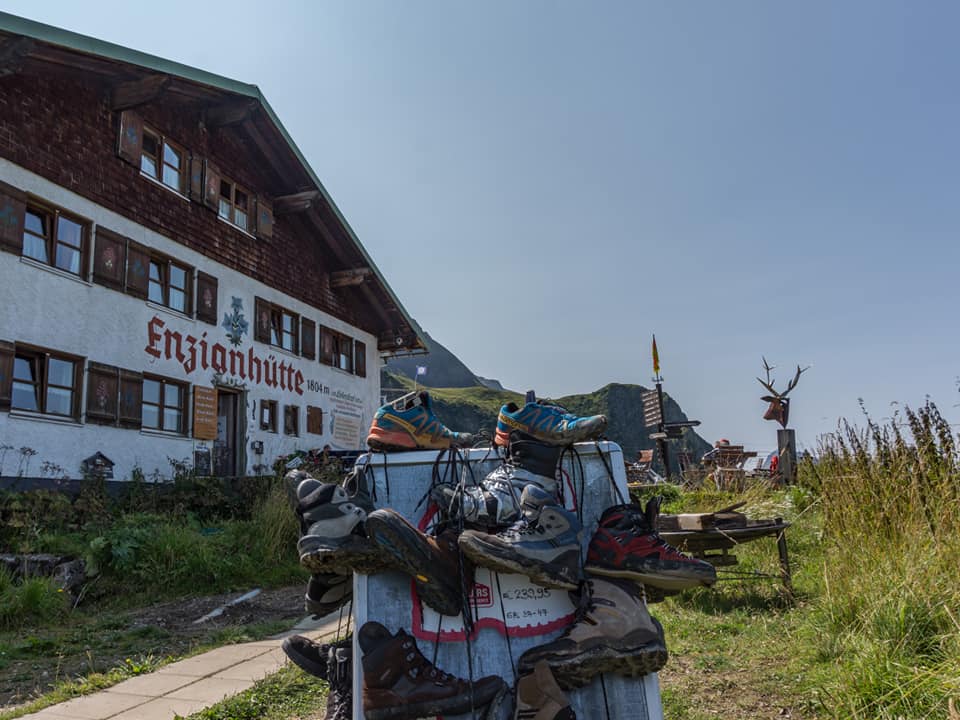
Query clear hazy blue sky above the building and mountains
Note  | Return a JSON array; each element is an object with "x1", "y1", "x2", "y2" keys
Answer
[{"x1": 0, "y1": 0, "x2": 960, "y2": 448}]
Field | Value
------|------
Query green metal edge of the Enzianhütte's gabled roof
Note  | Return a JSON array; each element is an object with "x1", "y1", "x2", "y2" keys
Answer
[{"x1": 0, "y1": 11, "x2": 427, "y2": 349}]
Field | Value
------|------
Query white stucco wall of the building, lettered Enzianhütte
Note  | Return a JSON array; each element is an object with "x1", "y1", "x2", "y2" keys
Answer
[{"x1": 0, "y1": 159, "x2": 380, "y2": 480}]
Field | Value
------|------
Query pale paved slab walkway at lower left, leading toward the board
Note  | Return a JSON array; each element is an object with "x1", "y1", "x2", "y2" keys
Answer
[{"x1": 16, "y1": 613, "x2": 337, "y2": 720}]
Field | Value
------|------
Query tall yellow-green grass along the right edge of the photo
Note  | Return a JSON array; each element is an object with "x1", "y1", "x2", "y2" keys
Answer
[{"x1": 801, "y1": 402, "x2": 960, "y2": 720}]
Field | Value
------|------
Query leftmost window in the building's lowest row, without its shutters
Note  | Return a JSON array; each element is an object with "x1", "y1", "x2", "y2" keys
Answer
[{"x1": 11, "y1": 348, "x2": 82, "y2": 417}]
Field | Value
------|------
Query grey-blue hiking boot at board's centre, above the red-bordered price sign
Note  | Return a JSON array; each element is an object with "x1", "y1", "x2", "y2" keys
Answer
[{"x1": 460, "y1": 485, "x2": 583, "y2": 590}]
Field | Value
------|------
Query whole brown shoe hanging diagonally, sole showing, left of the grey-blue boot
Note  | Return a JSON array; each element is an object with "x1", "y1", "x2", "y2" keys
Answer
[{"x1": 367, "y1": 508, "x2": 473, "y2": 615}]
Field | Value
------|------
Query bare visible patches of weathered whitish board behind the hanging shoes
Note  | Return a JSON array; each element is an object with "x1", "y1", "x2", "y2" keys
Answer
[{"x1": 353, "y1": 441, "x2": 663, "y2": 720}]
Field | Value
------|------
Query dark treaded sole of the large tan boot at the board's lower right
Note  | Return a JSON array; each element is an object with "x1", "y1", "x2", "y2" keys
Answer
[{"x1": 518, "y1": 643, "x2": 668, "y2": 690}]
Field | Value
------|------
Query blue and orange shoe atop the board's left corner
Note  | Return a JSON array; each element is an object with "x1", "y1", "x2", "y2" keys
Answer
[{"x1": 367, "y1": 391, "x2": 474, "y2": 450}]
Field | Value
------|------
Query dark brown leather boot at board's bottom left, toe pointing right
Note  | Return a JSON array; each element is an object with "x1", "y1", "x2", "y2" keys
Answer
[{"x1": 358, "y1": 622, "x2": 506, "y2": 720}]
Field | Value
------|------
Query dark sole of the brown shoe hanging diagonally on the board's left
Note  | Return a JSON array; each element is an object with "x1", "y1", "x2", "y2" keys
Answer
[{"x1": 366, "y1": 515, "x2": 463, "y2": 615}]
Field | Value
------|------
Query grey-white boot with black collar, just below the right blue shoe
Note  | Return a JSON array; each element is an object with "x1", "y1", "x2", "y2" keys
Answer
[{"x1": 430, "y1": 432, "x2": 562, "y2": 528}]
